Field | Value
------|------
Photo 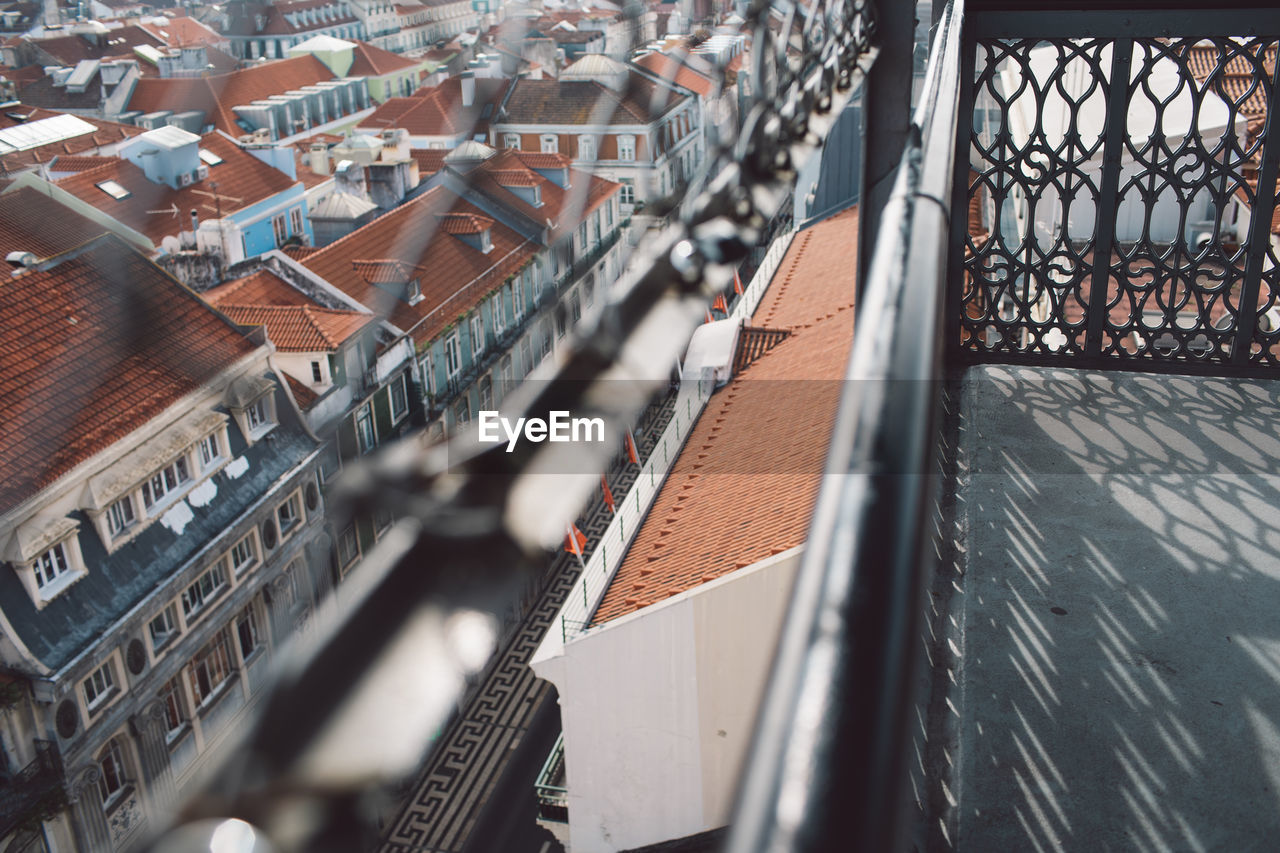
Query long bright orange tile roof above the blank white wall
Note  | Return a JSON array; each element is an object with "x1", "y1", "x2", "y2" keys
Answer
[{"x1": 593, "y1": 202, "x2": 858, "y2": 625}]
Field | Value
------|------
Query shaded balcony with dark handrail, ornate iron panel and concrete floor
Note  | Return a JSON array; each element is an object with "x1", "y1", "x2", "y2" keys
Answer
[{"x1": 728, "y1": 0, "x2": 1280, "y2": 850}]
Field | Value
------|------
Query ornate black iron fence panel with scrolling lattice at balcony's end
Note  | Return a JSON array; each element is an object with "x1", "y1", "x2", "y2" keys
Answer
[{"x1": 951, "y1": 18, "x2": 1280, "y2": 373}]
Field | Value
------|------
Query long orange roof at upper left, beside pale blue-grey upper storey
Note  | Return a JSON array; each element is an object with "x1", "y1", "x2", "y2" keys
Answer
[{"x1": 129, "y1": 54, "x2": 334, "y2": 136}]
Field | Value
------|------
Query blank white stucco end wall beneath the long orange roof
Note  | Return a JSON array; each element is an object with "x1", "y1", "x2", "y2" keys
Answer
[{"x1": 534, "y1": 548, "x2": 801, "y2": 853}]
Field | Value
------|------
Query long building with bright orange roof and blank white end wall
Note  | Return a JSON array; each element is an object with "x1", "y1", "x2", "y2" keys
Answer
[{"x1": 531, "y1": 202, "x2": 858, "y2": 853}]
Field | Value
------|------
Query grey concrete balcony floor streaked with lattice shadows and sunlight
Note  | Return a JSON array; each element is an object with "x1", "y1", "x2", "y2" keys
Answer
[{"x1": 947, "y1": 366, "x2": 1280, "y2": 853}]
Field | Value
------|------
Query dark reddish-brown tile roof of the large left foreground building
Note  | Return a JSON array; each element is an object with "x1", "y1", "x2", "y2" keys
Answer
[{"x1": 0, "y1": 237, "x2": 256, "y2": 512}]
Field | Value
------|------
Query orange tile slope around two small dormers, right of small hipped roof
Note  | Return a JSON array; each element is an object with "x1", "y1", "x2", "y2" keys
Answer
[{"x1": 301, "y1": 187, "x2": 539, "y2": 343}]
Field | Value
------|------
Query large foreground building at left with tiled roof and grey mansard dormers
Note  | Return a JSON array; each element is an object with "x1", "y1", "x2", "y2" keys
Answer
[{"x1": 0, "y1": 233, "x2": 329, "y2": 852}]
